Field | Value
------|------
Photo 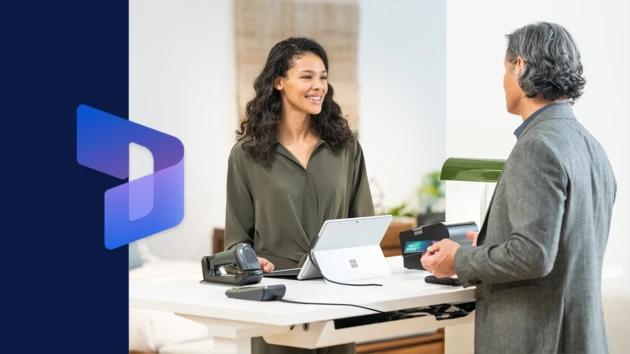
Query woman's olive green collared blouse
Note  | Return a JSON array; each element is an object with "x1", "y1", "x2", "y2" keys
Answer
[{"x1": 225, "y1": 134, "x2": 374, "y2": 270}]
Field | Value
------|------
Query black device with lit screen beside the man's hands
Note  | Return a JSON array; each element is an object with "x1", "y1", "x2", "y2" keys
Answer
[{"x1": 399, "y1": 221, "x2": 479, "y2": 270}]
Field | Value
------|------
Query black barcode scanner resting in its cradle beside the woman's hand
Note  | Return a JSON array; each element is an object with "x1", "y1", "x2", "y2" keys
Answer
[{"x1": 201, "y1": 243, "x2": 263, "y2": 285}]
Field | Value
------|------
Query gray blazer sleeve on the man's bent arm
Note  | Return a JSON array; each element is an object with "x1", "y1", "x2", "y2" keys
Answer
[{"x1": 455, "y1": 139, "x2": 568, "y2": 286}]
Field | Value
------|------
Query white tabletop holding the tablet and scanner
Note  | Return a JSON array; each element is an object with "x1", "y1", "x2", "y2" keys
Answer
[{"x1": 129, "y1": 256, "x2": 475, "y2": 326}]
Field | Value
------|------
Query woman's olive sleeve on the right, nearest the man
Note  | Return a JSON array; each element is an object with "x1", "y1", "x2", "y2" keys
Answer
[{"x1": 348, "y1": 141, "x2": 375, "y2": 218}]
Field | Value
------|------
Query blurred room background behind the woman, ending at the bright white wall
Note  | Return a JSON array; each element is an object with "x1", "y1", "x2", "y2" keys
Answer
[{"x1": 129, "y1": 0, "x2": 452, "y2": 260}]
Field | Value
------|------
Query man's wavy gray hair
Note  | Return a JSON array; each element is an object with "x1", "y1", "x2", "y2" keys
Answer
[{"x1": 505, "y1": 22, "x2": 586, "y2": 104}]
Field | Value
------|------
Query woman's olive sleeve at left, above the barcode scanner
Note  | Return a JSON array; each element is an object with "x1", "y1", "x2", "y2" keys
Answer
[{"x1": 225, "y1": 155, "x2": 254, "y2": 250}]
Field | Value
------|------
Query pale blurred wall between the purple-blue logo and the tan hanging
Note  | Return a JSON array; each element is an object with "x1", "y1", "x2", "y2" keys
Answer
[{"x1": 129, "y1": 0, "x2": 237, "y2": 261}]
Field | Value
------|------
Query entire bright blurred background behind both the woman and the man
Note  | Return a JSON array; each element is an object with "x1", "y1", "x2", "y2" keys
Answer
[{"x1": 129, "y1": 0, "x2": 630, "y2": 353}]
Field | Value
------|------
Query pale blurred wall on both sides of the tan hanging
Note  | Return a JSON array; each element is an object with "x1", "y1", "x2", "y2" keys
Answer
[{"x1": 129, "y1": 0, "x2": 446, "y2": 261}]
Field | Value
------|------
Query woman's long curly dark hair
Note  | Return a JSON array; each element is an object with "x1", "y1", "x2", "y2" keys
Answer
[{"x1": 236, "y1": 37, "x2": 354, "y2": 165}]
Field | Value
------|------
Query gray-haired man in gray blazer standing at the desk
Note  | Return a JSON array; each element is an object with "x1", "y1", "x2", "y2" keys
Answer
[{"x1": 422, "y1": 23, "x2": 617, "y2": 354}]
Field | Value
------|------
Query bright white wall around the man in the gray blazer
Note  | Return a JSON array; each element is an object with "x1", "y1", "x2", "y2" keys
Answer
[{"x1": 446, "y1": 0, "x2": 630, "y2": 353}]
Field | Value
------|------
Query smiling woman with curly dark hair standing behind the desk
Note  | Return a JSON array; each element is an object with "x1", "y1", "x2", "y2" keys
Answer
[{"x1": 225, "y1": 38, "x2": 374, "y2": 354}]
